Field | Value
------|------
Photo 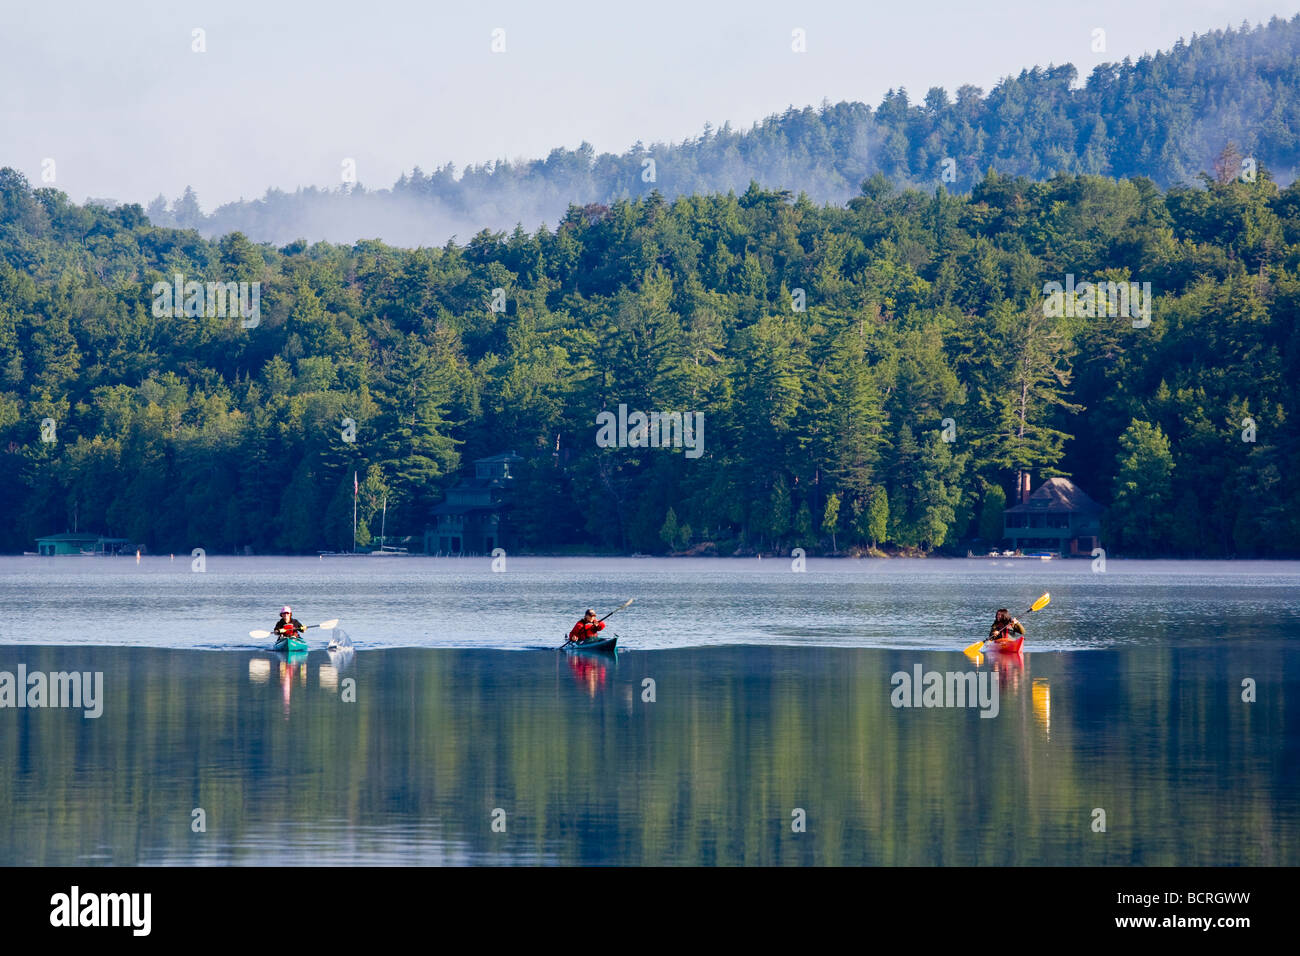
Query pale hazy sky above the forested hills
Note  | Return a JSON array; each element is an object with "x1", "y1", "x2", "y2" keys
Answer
[{"x1": 0, "y1": 0, "x2": 1297, "y2": 211}]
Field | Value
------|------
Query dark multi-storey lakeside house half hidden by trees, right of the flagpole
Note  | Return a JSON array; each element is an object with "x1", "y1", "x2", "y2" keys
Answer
[{"x1": 424, "y1": 451, "x2": 524, "y2": 554}]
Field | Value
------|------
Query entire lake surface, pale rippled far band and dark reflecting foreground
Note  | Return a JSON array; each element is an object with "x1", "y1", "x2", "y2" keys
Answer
[{"x1": 0, "y1": 555, "x2": 1300, "y2": 865}]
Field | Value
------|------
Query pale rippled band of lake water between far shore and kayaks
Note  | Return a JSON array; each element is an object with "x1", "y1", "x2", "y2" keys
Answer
[{"x1": 0, "y1": 554, "x2": 1300, "y2": 650}]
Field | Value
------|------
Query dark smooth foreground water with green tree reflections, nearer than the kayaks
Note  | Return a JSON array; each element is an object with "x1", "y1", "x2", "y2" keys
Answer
[{"x1": 0, "y1": 641, "x2": 1300, "y2": 866}]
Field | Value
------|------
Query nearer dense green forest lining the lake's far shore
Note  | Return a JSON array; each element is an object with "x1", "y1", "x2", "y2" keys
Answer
[{"x1": 0, "y1": 147, "x2": 1300, "y2": 555}]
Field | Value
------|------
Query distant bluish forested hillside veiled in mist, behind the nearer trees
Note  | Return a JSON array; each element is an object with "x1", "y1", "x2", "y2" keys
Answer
[{"x1": 126, "y1": 17, "x2": 1300, "y2": 246}]
